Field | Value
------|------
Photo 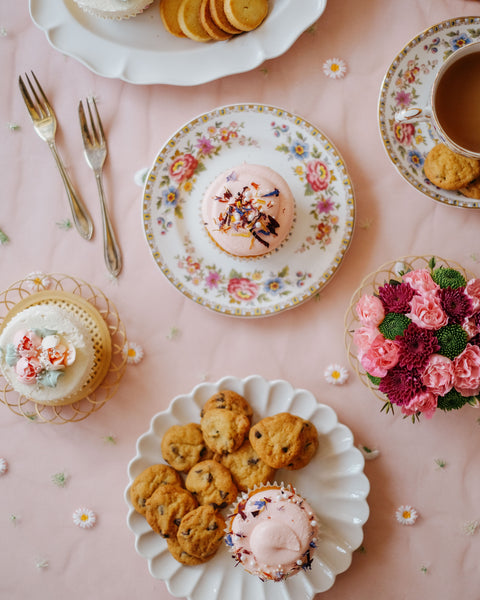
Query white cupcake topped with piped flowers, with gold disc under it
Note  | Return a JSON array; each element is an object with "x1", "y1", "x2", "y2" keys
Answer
[{"x1": 0, "y1": 291, "x2": 111, "y2": 406}]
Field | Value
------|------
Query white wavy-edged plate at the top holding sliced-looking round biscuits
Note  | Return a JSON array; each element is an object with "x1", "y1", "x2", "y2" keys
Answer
[{"x1": 30, "y1": 0, "x2": 327, "y2": 85}]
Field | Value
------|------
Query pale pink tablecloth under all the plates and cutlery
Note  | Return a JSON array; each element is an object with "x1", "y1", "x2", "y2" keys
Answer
[{"x1": 0, "y1": 0, "x2": 480, "y2": 600}]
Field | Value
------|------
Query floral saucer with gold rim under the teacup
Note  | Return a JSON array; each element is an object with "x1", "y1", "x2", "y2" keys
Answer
[{"x1": 379, "y1": 17, "x2": 480, "y2": 208}]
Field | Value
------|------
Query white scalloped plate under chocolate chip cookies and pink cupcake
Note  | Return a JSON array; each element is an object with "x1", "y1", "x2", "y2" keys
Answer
[{"x1": 125, "y1": 375, "x2": 370, "y2": 600}]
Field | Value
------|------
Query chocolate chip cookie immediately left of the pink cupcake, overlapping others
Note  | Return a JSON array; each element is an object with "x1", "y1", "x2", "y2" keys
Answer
[{"x1": 177, "y1": 505, "x2": 225, "y2": 559}]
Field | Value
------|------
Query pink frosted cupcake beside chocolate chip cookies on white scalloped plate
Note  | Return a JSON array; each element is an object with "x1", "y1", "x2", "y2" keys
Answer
[{"x1": 225, "y1": 484, "x2": 318, "y2": 581}]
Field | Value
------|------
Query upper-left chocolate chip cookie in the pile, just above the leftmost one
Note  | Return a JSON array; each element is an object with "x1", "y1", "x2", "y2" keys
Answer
[{"x1": 161, "y1": 423, "x2": 212, "y2": 473}]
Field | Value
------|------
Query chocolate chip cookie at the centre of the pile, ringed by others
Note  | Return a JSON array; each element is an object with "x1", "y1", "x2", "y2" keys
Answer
[{"x1": 185, "y1": 460, "x2": 237, "y2": 509}]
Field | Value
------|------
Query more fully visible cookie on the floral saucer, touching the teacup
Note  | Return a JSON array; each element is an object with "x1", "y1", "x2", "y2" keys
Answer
[{"x1": 423, "y1": 144, "x2": 480, "y2": 190}]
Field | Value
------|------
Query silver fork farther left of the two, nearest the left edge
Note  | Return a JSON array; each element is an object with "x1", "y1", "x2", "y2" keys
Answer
[{"x1": 18, "y1": 71, "x2": 93, "y2": 240}]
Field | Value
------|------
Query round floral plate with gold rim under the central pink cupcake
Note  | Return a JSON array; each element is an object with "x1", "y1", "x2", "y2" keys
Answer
[{"x1": 143, "y1": 104, "x2": 355, "y2": 317}]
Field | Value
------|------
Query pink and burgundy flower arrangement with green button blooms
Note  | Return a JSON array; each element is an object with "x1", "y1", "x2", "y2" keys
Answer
[{"x1": 351, "y1": 257, "x2": 480, "y2": 421}]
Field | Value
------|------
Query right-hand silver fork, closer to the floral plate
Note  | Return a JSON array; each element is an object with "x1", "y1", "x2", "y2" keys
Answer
[{"x1": 78, "y1": 98, "x2": 122, "y2": 277}]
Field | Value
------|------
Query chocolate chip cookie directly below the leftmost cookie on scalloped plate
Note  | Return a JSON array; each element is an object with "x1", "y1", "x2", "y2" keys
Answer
[{"x1": 145, "y1": 485, "x2": 198, "y2": 538}]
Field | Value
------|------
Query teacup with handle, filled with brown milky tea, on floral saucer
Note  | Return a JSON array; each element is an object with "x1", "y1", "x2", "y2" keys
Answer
[{"x1": 395, "y1": 42, "x2": 480, "y2": 159}]
